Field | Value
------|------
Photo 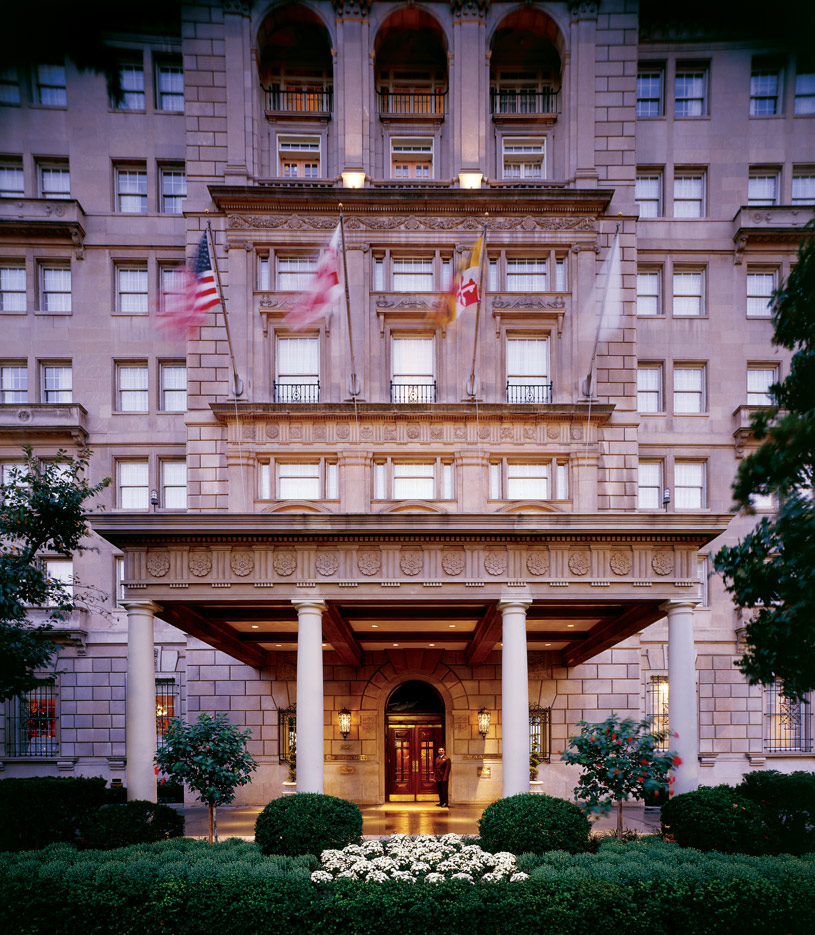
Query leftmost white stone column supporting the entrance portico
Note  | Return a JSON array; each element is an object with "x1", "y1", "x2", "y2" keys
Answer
[{"x1": 123, "y1": 601, "x2": 161, "y2": 802}]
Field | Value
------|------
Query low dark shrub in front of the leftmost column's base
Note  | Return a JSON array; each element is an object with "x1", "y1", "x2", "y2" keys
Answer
[{"x1": 79, "y1": 799, "x2": 184, "y2": 851}]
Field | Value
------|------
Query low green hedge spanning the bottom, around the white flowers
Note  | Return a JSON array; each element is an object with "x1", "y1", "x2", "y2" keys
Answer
[{"x1": 0, "y1": 839, "x2": 815, "y2": 935}]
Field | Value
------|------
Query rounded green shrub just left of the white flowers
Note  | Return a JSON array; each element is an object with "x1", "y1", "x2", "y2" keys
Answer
[{"x1": 255, "y1": 792, "x2": 362, "y2": 856}]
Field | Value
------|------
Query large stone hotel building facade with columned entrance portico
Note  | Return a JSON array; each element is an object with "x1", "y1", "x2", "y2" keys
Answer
[{"x1": 0, "y1": 0, "x2": 815, "y2": 804}]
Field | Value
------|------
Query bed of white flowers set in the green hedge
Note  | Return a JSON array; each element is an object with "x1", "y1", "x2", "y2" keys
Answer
[{"x1": 311, "y1": 834, "x2": 528, "y2": 883}]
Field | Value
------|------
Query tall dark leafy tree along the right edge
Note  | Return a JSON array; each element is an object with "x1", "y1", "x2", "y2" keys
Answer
[{"x1": 713, "y1": 230, "x2": 815, "y2": 699}]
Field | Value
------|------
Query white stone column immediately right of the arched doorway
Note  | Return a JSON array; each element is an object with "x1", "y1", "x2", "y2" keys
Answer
[{"x1": 498, "y1": 598, "x2": 532, "y2": 798}]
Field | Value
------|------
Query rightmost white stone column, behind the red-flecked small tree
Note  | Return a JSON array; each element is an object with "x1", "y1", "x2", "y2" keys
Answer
[{"x1": 659, "y1": 601, "x2": 699, "y2": 793}]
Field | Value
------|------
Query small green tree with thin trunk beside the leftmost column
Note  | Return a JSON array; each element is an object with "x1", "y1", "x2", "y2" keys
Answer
[{"x1": 156, "y1": 714, "x2": 257, "y2": 844}]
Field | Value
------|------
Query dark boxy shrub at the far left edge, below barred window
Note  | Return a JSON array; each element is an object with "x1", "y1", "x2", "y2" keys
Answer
[{"x1": 0, "y1": 776, "x2": 109, "y2": 851}]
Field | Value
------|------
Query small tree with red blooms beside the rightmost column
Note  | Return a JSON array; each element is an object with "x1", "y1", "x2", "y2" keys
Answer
[{"x1": 558, "y1": 714, "x2": 682, "y2": 839}]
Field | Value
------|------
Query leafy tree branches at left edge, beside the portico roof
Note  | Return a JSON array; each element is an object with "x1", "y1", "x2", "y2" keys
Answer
[{"x1": 0, "y1": 448, "x2": 110, "y2": 701}]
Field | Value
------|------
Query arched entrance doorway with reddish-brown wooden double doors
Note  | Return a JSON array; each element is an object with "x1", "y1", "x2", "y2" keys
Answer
[{"x1": 385, "y1": 680, "x2": 444, "y2": 802}]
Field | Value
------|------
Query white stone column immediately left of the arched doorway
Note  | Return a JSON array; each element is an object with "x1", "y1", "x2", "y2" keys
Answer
[{"x1": 292, "y1": 599, "x2": 325, "y2": 792}]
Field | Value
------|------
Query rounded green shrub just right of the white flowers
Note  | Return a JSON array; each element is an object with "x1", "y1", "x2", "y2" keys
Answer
[{"x1": 478, "y1": 793, "x2": 591, "y2": 854}]
